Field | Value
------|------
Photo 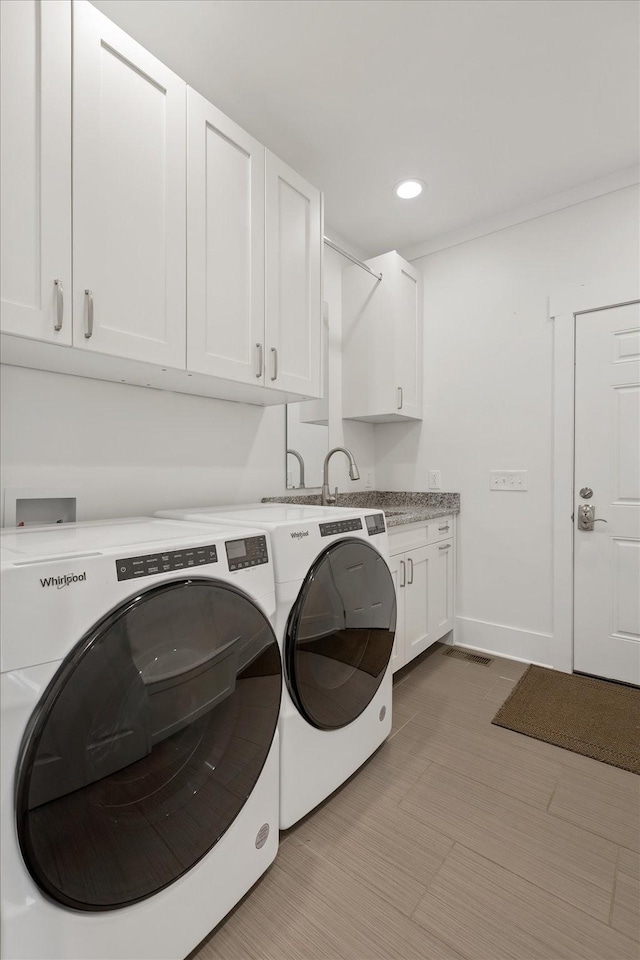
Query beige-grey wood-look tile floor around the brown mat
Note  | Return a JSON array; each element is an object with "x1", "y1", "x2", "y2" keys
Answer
[{"x1": 191, "y1": 645, "x2": 640, "y2": 960}]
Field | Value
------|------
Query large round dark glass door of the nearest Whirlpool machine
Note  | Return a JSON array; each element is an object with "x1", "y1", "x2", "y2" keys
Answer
[{"x1": 17, "y1": 579, "x2": 282, "y2": 910}]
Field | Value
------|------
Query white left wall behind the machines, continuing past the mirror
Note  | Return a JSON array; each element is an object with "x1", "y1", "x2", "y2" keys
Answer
[{"x1": 1, "y1": 240, "x2": 374, "y2": 520}]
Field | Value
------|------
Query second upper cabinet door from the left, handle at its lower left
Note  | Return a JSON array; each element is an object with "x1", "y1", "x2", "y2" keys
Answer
[{"x1": 73, "y1": 0, "x2": 186, "y2": 369}]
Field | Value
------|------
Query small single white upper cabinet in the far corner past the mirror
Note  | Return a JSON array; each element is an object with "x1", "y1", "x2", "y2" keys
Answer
[{"x1": 342, "y1": 250, "x2": 423, "y2": 423}]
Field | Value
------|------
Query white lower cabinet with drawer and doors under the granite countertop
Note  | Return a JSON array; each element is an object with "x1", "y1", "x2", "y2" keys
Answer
[{"x1": 389, "y1": 517, "x2": 454, "y2": 673}]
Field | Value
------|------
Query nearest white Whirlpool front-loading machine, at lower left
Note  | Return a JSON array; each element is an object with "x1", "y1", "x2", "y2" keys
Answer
[{"x1": 0, "y1": 518, "x2": 282, "y2": 960}]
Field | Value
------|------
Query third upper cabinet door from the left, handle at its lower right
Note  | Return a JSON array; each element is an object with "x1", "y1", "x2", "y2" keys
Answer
[{"x1": 187, "y1": 88, "x2": 265, "y2": 384}]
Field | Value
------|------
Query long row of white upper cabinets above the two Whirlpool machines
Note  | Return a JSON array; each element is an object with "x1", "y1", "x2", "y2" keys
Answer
[{"x1": 0, "y1": 0, "x2": 322, "y2": 405}]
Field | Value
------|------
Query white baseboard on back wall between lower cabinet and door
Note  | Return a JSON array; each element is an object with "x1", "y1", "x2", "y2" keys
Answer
[{"x1": 453, "y1": 617, "x2": 571, "y2": 673}]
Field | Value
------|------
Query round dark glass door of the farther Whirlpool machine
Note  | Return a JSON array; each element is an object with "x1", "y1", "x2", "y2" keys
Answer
[{"x1": 285, "y1": 539, "x2": 396, "y2": 730}]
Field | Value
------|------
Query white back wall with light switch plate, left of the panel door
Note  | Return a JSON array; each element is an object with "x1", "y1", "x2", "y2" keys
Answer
[{"x1": 376, "y1": 186, "x2": 640, "y2": 665}]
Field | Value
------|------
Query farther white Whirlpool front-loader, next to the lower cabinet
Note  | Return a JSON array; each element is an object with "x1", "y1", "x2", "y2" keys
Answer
[{"x1": 155, "y1": 503, "x2": 396, "y2": 829}]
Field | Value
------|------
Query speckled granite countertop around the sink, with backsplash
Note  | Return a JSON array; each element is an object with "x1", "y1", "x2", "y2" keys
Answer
[{"x1": 262, "y1": 490, "x2": 460, "y2": 527}]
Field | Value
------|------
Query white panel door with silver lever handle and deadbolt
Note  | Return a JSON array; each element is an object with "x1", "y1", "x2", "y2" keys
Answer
[{"x1": 574, "y1": 303, "x2": 640, "y2": 684}]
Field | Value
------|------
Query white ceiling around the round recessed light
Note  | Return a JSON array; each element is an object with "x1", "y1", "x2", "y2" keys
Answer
[{"x1": 94, "y1": 0, "x2": 640, "y2": 255}]
